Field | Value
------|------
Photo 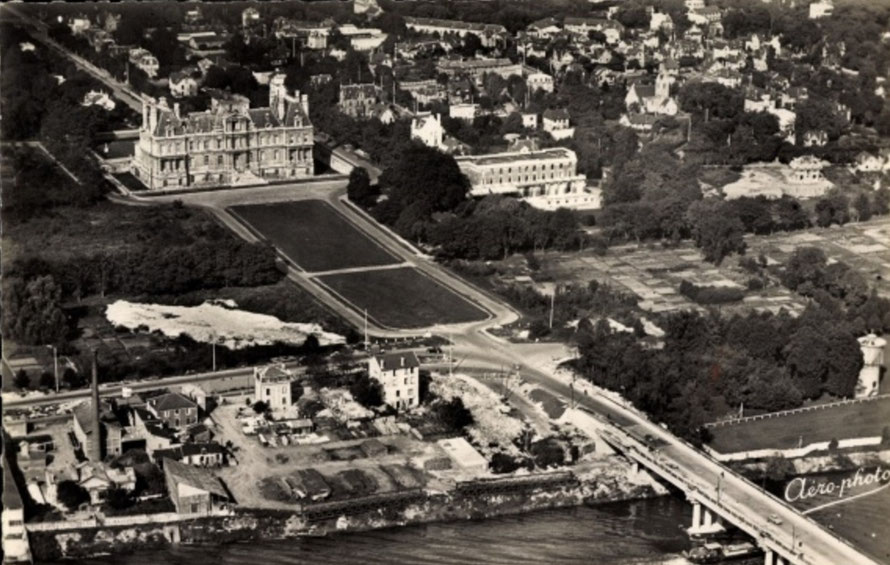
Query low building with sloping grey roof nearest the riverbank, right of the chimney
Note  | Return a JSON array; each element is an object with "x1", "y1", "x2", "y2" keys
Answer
[{"x1": 162, "y1": 459, "x2": 232, "y2": 516}]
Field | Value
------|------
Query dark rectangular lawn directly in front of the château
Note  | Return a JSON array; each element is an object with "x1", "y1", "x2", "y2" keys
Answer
[{"x1": 230, "y1": 200, "x2": 399, "y2": 272}]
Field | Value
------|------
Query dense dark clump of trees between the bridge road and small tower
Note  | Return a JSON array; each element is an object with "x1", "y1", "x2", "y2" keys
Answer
[{"x1": 577, "y1": 304, "x2": 862, "y2": 442}]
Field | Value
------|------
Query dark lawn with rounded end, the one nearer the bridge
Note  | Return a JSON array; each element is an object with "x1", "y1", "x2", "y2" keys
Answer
[{"x1": 318, "y1": 268, "x2": 487, "y2": 329}]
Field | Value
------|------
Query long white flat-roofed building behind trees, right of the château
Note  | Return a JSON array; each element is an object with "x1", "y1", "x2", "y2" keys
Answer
[{"x1": 456, "y1": 147, "x2": 600, "y2": 209}]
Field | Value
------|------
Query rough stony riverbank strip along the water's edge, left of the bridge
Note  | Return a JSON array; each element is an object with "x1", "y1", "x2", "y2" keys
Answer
[{"x1": 29, "y1": 460, "x2": 665, "y2": 562}]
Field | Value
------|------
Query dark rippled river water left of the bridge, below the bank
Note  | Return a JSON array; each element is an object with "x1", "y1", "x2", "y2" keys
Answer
[{"x1": 55, "y1": 497, "x2": 692, "y2": 565}]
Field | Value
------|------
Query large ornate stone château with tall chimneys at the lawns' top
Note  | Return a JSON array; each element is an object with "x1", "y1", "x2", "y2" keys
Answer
[{"x1": 133, "y1": 75, "x2": 313, "y2": 190}]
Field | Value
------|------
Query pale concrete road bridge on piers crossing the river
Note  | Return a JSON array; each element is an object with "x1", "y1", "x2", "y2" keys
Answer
[{"x1": 603, "y1": 426, "x2": 876, "y2": 565}]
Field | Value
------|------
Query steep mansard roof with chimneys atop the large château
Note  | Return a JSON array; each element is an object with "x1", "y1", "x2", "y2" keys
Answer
[{"x1": 154, "y1": 92, "x2": 310, "y2": 137}]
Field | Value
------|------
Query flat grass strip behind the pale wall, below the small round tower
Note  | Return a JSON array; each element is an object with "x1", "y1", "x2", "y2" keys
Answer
[{"x1": 710, "y1": 397, "x2": 890, "y2": 453}]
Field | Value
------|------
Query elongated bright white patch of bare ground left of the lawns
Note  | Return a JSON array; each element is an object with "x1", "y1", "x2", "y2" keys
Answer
[{"x1": 105, "y1": 300, "x2": 346, "y2": 349}]
